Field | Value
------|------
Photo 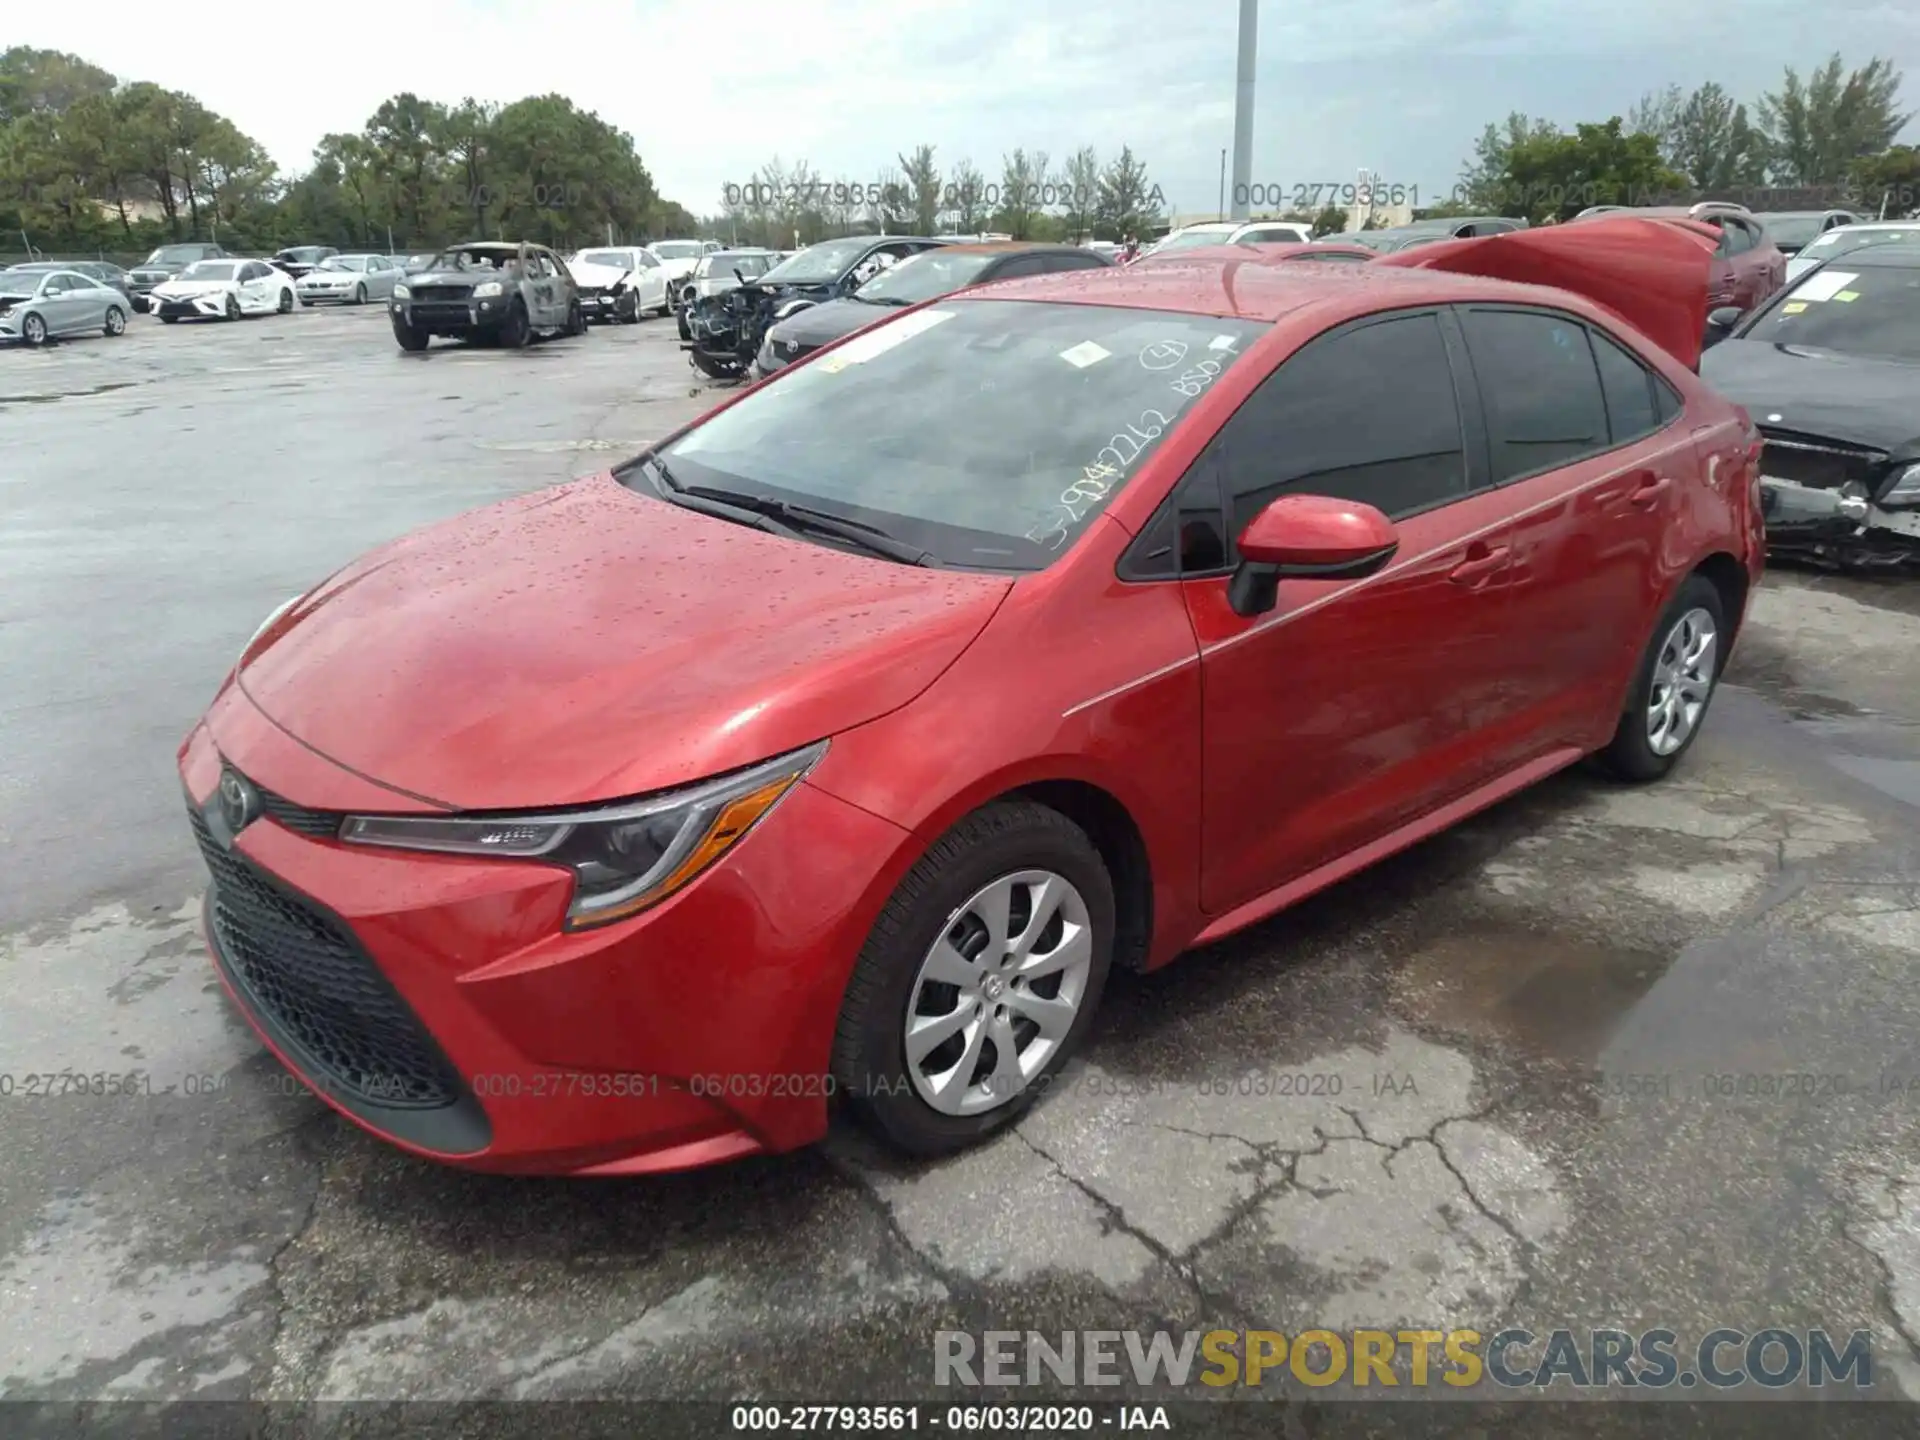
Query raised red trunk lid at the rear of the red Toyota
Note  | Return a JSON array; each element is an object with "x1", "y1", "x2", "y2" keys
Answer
[{"x1": 1373, "y1": 215, "x2": 1720, "y2": 371}]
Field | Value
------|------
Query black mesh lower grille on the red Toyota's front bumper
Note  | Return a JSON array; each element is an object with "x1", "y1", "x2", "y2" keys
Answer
[{"x1": 188, "y1": 804, "x2": 463, "y2": 1110}]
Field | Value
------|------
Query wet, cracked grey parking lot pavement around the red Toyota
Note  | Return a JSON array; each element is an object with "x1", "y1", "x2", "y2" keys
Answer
[{"x1": 0, "y1": 307, "x2": 1920, "y2": 1423}]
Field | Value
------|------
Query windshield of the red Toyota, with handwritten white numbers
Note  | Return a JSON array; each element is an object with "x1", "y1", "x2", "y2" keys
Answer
[{"x1": 660, "y1": 300, "x2": 1267, "y2": 570}]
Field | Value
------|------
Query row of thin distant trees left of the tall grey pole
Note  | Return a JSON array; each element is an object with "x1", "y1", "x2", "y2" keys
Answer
[{"x1": 701, "y1": 144, "x2": 1169, "y2": 250}]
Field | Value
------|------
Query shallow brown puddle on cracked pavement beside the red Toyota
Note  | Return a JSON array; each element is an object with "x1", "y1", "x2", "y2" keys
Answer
[{"x1": 1394, "y1": 927, "x2": 1674, "y2": 1066}]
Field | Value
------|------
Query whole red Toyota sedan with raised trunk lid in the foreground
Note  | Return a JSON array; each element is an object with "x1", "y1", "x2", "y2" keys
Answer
[{"x1": 180, "y1": 221, "x2": 1761, "y2": 1175}]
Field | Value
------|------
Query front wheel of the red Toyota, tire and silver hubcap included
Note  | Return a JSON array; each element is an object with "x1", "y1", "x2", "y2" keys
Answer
[{"x1": 833, "y1": 801, "x2": 1114, "y2": 1156}]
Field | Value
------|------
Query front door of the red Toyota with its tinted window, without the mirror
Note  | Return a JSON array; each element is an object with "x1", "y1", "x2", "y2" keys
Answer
[{"x1": 1183, "y1": 311, "x2": 1509, "y2": 914}]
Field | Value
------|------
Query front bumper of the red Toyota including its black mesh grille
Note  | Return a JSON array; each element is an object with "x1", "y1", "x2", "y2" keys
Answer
[{"x1": 179, "y1": 685, "x2": 904, "y2": 1175}]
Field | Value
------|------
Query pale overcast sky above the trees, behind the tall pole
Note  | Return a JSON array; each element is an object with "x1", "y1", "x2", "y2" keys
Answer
[{"x1": 8, "y1": 0, "x2": 1920, "y2": 213}]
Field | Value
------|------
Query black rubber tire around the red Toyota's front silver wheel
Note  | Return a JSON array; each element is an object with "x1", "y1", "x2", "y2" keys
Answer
[{"x1": 833, "y1": 801, "x2": 1114, "y2": 1156}]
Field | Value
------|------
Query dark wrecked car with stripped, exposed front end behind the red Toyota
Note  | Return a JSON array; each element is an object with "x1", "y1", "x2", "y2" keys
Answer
[{"x1": 680, "y1": 234, "x2": 945, "y2": 380}]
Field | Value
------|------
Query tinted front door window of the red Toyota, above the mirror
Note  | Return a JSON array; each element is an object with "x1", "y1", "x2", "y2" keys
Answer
[{"x1": 1200, "y1": 315, "x2": 1467, "y2": 534}]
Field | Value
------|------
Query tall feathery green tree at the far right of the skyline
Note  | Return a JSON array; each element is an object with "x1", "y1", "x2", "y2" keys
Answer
[{"x1": 1753, "y1": 54, "x2": 1912, "y2": 184}]
